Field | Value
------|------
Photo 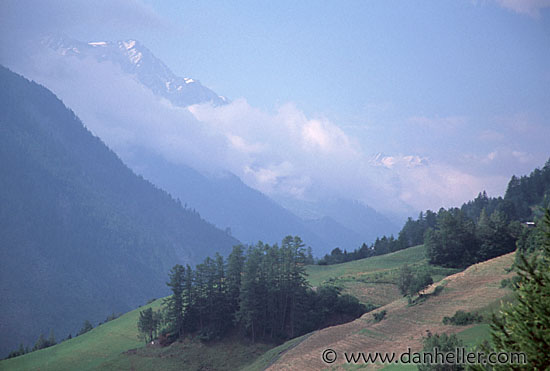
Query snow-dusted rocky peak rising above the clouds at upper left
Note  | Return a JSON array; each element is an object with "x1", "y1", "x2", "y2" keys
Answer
[{"x1": 43, "y1": 37, "x2": 228, "y2": 107}]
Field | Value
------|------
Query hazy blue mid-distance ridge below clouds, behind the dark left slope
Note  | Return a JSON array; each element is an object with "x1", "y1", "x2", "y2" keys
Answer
[{"x1": 125, "y1": 150, "x2": 335, "y2": 251}]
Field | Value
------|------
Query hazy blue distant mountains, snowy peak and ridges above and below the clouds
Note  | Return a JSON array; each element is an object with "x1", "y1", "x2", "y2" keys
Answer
[{"x1": 43, "y1": 37, "x2": 398, "y2": 256}]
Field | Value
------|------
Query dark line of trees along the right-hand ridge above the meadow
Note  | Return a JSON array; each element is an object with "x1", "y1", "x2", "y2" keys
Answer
[{"x1": 318, "y1": 159, "x2": 550, "y2": 267}]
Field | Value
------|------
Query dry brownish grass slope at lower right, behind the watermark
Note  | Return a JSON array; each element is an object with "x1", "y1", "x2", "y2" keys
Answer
[{"x1": 267, "y1": 253, "x2": 514, "y2": 371}]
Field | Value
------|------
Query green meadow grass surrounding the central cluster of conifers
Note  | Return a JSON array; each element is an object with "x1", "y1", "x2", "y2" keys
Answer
[{"x1": 0, "y1": 246, "x2": 500, "y2": 371}]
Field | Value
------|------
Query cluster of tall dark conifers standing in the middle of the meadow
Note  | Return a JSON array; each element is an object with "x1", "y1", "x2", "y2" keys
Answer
[{"x1": 138, "y1": 236, "x2": 367, "y2": 341}]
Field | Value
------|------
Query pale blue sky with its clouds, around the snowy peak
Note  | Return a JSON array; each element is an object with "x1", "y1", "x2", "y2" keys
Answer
[{"x1": 0, "y1": 0, "x2": 550, "y2": 217}]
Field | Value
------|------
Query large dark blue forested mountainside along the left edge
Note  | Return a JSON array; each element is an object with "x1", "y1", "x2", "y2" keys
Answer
[{"x1": 0, "y1": 67, "x2": 238, "y2": 354}]
